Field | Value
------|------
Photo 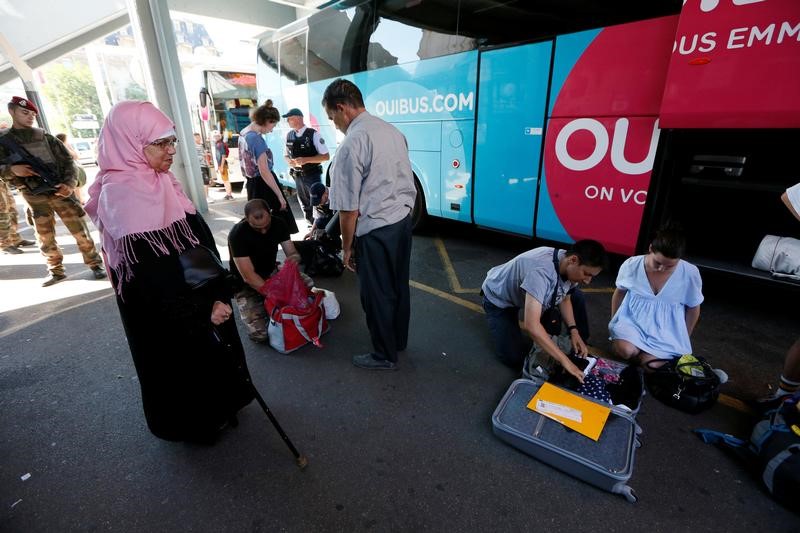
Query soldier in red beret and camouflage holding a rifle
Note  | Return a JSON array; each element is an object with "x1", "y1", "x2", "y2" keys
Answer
[{"x1": 0, "y1": 96, "x2": 106, "y2": 287}]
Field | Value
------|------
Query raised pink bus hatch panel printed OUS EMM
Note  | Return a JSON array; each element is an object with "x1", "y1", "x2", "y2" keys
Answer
[{"x1": 661, "y1": 0, "x2": 800, "y2": 128}]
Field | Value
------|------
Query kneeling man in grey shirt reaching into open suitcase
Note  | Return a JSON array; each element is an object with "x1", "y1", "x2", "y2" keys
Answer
[{"x1": 481, "y1": 239, "x2": 606, "y2": 382}]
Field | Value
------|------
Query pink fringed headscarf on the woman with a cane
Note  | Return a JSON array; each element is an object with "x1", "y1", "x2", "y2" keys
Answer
[{"x1": 85, "y1": 101, "x2": 199, "y2": 292}]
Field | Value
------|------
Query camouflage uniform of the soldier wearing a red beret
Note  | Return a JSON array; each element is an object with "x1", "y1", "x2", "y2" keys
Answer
[{"x1": 0, "y1": 128, "x2": 103, "y2": 276}]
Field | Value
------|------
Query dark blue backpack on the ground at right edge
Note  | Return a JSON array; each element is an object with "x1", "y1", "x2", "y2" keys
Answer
[{"x1": 694, "y1": 392, "x2": 800, "y2": 513}]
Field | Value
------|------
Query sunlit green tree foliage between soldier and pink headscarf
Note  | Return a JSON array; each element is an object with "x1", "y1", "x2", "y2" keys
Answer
[{"x1": 42, "y1": 61, "x2": 103, "y2": 137}]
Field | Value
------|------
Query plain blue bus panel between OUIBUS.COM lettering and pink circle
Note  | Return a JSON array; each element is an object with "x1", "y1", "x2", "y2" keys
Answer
[{"x1": 473, "y1": 41, "x2": 552, "y2": 236}]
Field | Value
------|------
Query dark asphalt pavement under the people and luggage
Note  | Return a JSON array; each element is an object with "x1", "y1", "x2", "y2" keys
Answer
[{"x1": 0, "y1": 181, "x2": 800, "y2": 532}]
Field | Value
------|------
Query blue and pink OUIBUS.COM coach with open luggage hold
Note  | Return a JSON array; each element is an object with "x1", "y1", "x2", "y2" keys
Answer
[{"x1": 257, "y1": 0, "x2": 800, "y2": 277}]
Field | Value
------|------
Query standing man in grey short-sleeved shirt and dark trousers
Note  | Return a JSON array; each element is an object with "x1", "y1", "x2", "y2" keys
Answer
[{"x1": 322, "y1": 79, "x2": 417, "y2": 370}]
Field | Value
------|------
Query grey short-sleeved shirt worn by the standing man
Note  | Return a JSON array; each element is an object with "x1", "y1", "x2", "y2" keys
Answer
[{"x1": 330, "y1": 111, "x2": 417, "y2": 236}]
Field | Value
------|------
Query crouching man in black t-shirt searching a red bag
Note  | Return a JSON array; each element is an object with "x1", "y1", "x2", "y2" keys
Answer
[{"x1": 228, "y1": 198, "x2": 313, "y2": 342}]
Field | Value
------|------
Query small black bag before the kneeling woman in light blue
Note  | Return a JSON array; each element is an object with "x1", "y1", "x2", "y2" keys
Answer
[{"x1": 644, "y1": 356, "x2": 720, "y2": 414}]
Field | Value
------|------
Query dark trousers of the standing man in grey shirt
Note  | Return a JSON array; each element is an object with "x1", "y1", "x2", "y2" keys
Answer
[{"x1": 356, "y1": 215, "x2": 411, "y2": 363}]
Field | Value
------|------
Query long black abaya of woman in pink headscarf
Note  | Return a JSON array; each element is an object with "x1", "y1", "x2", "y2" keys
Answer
[{"x1": 114, "y1": 214, "x2": 253, "y2": 443}]
